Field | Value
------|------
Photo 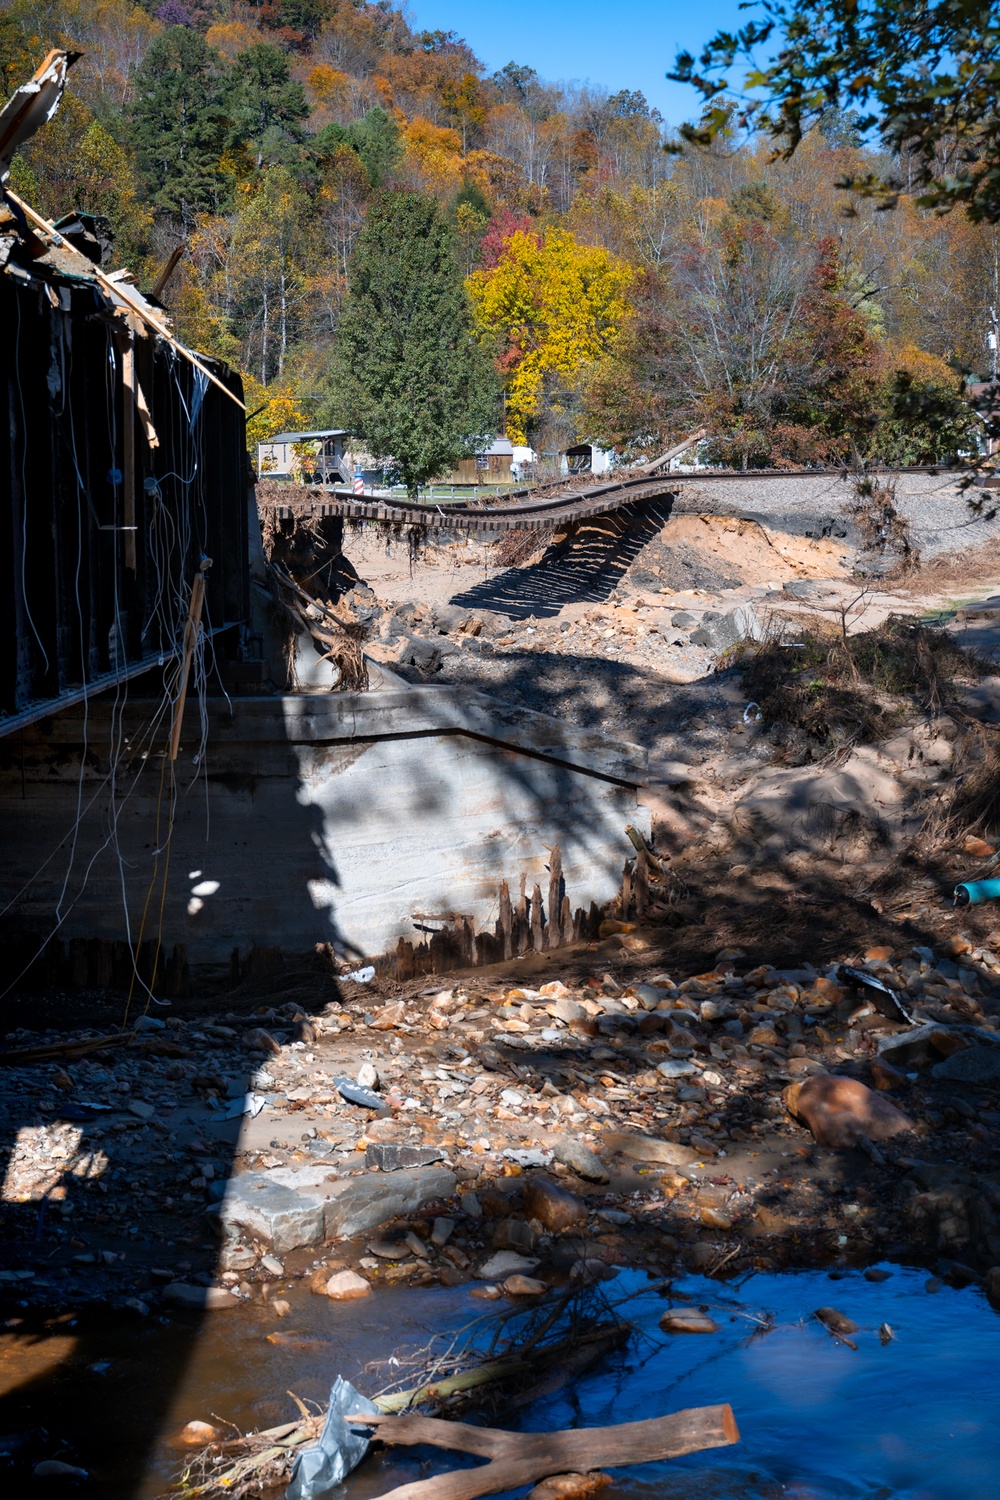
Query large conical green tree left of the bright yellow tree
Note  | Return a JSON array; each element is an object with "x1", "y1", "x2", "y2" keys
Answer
[{"x1": 330, "y1": 192, "x2": 499, "y2": 495}]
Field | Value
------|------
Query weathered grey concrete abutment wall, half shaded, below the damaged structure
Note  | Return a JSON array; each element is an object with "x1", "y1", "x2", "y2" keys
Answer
[{"x1": 0, "y1": 687, "x2": 648, "y2": 966}]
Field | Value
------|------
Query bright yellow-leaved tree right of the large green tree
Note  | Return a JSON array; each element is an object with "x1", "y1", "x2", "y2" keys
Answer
[{"x1": 468, "y1": 228, "x2": 636, "y2": 443}]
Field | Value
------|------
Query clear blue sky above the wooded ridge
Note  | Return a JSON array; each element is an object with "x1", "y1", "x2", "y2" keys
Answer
[{"x1": 409, "y1": 0, "x2": 754, "y2": 125}]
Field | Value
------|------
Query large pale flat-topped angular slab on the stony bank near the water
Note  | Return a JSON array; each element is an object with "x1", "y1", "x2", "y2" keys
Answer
[{"x1": 211, "y1": 1167, "x2": 456, "y2": 1256}]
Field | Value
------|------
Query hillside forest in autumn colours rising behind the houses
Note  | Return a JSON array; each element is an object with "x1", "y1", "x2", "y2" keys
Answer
[{"x1": 0, "y1": 0, "x2": 1000, "y2": 467}]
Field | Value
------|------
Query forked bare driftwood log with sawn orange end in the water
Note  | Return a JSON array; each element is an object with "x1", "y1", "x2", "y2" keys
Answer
[{"x1": 351, "y1": 1406, "x2": 739, "y2": 1500}]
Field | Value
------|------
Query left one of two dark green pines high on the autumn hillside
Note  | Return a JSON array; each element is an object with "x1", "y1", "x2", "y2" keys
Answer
[{"x1": 130, "y1": 26, "x2": 231, "y2": 225}]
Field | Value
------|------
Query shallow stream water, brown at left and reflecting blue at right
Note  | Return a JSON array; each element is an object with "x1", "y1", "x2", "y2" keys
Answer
[{"x1": 0, "y1": 1268, "x2": 1000, "y2": 1500}]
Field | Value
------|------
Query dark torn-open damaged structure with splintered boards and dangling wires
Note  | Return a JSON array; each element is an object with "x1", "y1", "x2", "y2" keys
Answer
[{"x1": 0, "y1": 53, "x2": 250, "y2": 735}]
